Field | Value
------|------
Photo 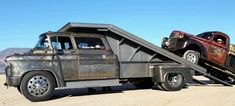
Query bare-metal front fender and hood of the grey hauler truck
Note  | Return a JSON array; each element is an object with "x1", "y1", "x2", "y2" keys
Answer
[{"x1": 6, "y1": 57, "x2": 65, "y2": 87}]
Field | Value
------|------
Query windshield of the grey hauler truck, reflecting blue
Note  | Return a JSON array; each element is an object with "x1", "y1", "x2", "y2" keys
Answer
[{"x1": 34, "y1": 36, "x2": 49, "y2": 49}]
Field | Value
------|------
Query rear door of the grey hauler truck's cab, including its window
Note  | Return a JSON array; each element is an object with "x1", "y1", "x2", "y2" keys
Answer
[{"x1": 75, "y1": 37, "x2": 118, "y2": 80}]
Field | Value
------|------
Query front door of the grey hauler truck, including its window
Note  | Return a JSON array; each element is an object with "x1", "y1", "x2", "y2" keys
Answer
[{"x1": 51, "y1": 36, "x2": 78, "y2": 81}]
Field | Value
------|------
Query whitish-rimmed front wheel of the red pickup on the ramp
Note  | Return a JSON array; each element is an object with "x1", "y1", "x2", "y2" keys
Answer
[{"x1": 183, "y1": 50, "x2": 200, "y2": 64}]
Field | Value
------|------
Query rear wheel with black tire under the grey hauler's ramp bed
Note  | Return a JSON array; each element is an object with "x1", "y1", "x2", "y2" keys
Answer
[{"x1": 161, "y1": 73, "x2": 184, "y2": 91}]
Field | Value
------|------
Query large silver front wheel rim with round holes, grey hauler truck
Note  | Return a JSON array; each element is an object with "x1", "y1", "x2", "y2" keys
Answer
[{"x1": 27, "y1": 76, "x2": 50, "y2": 97}]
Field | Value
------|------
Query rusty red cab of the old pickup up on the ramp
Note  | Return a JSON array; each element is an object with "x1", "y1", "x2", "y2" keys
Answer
[{"x1": 197, "y1": 32, "x2": 229, "y2": 66}]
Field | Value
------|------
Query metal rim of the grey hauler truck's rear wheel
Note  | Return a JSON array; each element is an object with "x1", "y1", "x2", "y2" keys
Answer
[{"x1": 167, "y1": 74, "x2": 182, "y2": 86}]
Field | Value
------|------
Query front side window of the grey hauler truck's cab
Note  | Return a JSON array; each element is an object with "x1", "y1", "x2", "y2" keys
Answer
[{"x1": 51, "y1": 37, "x2": 73, "y2": 49}]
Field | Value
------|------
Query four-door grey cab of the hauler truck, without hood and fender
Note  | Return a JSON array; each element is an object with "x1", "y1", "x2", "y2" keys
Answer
[{"x1": 33, "y1": 32, "x2": 119, "y2": 80}]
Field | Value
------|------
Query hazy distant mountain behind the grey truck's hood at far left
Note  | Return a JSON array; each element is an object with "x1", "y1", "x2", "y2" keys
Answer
[{"x1": 0, "y1": 48, "x2": 30, "y2": 73}]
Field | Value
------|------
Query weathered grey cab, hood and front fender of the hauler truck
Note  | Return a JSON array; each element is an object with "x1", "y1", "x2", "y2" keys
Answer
[{"x1": 6, "y1": 32, "x2": 119, "y2": 87}]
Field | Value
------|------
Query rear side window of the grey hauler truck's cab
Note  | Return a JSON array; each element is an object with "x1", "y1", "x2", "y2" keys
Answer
[{"x1": 75, "y1": 37, "x2": 105, "y2": 49}]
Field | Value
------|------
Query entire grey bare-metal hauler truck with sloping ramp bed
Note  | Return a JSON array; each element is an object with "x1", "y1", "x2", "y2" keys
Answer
[{"x1": 5, "y1": 23, "x2": 195, "y2": 101}]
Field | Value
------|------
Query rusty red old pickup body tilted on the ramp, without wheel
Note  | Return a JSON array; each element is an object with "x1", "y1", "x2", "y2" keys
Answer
[{"x1": 162, "y1": 31, "x2": 235, "y2": 72}]
